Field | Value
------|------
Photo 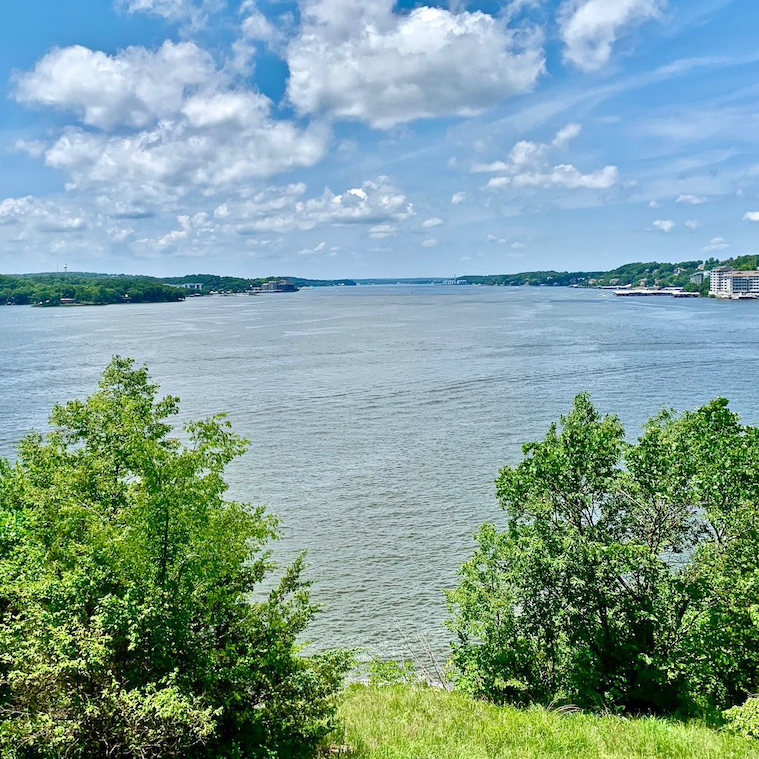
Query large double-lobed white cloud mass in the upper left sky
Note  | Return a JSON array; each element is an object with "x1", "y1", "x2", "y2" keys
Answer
[{"x1": 16, "y1": 42, "x2": 329, "y2": 200}]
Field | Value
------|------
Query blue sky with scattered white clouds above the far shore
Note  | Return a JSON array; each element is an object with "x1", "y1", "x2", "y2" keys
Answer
[{"x1": 0, "y1": 0, "x2": 759, "y2": 278}]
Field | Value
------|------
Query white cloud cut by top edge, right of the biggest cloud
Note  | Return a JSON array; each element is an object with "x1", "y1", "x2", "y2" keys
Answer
[{"x1": 559, "y1": 0, "x2": 664, "y2": 71}]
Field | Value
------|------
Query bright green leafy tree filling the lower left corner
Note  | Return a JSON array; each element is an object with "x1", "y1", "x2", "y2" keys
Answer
[{"x1": 0, "y1": 357, "x2": 349, "y2": 757}]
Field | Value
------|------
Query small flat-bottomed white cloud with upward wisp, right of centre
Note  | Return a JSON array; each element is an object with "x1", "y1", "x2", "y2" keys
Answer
[{"x1": 472, "y1": 124, "x2": 619, "y2": 190}]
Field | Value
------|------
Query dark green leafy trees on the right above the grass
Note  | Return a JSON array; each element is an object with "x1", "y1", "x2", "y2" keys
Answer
[{"x1": 448, "y1": 394, "x2": 759, "y2": 713}]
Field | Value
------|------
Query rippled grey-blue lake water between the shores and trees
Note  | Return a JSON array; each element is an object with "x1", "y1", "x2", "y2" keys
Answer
[{"x1": 0, "y1": 286, "x2": 759, "y2": 655}]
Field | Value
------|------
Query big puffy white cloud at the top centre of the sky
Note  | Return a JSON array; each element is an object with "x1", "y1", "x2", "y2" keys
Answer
[{"x1": 287, "y1": 0, "x2": 544, "y2": 129}]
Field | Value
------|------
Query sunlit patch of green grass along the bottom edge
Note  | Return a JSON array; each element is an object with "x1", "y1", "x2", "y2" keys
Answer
[{"x1": 332, "y1": 684, "x2": 759, "y2": 759}]
